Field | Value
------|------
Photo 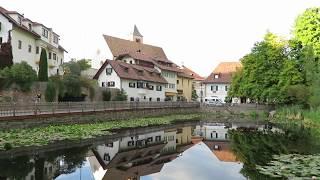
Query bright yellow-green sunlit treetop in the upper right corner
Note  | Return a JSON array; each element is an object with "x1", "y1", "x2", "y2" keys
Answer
[{"x1": 293, "y1": 8, "x2": 320, "y2": 56}]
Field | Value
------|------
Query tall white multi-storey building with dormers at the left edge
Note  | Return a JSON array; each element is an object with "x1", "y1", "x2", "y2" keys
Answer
[{"x1": 0, "y1": 7, "x2": 66, "y2": 76}]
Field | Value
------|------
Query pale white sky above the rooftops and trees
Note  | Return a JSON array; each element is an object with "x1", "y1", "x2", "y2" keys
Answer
[{"x1": 0, "y1": 0, "x2": 320, "y2": 76}]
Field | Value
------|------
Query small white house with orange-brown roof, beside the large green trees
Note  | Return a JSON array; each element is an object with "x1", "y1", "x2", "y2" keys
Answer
[{"x1": 203, "y1": 62, "x2": 241, "y2": 102}]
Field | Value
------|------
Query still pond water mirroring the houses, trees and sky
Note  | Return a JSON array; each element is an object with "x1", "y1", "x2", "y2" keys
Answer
[{"x1": 0, "y1": 121, "x2": 320, "y2": 180}]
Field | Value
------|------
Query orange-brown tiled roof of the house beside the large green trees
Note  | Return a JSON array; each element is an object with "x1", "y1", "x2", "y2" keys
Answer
[{"x1": 203, "y1": 62, "x2": 242, "y2": 84}]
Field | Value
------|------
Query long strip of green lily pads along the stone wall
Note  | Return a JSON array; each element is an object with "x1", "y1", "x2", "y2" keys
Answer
[{"x1": 0, "y1": 114, "x2": 201, "y2": 150}]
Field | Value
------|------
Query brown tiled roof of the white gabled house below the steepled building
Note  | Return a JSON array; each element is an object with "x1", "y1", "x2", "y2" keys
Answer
[{"x1": 93, "y1": 60, "x2": 167, "y2": 84}]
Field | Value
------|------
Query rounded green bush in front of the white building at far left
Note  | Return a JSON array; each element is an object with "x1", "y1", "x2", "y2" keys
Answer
[{"x1": 0, "y1": 62, "x2": 37, "y2": 91}]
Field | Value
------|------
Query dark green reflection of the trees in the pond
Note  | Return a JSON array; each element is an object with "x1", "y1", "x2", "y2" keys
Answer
[{"x1": 229, "y1": 125, "x2": 320, "y2": 180}]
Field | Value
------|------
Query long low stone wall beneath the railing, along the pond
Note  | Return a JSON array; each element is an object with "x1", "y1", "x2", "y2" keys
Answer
[{"x1": 0, "y1": 108, "x2": 200, "y2": 130}]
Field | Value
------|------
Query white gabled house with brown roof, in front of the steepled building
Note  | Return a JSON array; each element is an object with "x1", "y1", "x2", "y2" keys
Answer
[{"x1": 94, "y1": 60, "x2": 167, "y2": 102}]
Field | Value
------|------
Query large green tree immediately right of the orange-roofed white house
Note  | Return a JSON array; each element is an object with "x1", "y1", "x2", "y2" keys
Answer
[{"x1": 229, "y1": 32, "x2": 287, "y2": 103}]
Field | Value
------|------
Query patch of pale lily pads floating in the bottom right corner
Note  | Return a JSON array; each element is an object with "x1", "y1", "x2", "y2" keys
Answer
[{"x1": 257, "y1": 154, "x2": 320, "y2": 179}]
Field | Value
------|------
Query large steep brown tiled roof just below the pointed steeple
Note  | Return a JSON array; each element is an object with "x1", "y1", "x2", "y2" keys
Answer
[{"x1": 103, "y1": 35, "x2": 167, "y2": 60}]
